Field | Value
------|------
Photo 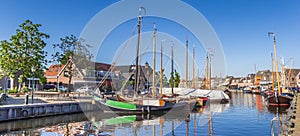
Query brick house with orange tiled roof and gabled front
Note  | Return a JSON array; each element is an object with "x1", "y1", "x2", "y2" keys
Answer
[{"x1": 45, "y1": 61, "x2": 115, "y2": 90}]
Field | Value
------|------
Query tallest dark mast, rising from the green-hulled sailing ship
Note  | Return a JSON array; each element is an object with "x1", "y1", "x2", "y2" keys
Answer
[{"x1": 134, "y1": 7, "x2": 145, "y2": 98}]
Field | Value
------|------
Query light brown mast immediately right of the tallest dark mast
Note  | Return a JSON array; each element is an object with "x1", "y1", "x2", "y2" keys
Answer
[{"x1": 152, "y1": 24, "x2": 156, "y2": 97}]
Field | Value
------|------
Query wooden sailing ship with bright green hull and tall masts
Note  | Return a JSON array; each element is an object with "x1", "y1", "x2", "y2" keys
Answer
[{"x1": 93, "y1": 7, "x2": 188, "y2": 114}]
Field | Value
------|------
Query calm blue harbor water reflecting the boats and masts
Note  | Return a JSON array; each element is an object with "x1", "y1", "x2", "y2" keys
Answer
[{"x1": 0, "y1": 93, "x2": 285, "y2": 136}]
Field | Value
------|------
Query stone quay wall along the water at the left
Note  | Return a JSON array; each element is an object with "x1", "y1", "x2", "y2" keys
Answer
[{"x1": 0, "y1": 96, "x2": 97, "y2": 122}]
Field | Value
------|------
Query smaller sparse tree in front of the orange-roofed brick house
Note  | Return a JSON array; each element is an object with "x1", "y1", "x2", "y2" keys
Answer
[{"x1": 51, "y1": 35, "x2": 93, "y2": 91}]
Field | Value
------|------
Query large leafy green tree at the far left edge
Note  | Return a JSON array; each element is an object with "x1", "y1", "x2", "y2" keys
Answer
[{"x1": 0, "y1": 20, "x2": 49, "y2": 90}]
